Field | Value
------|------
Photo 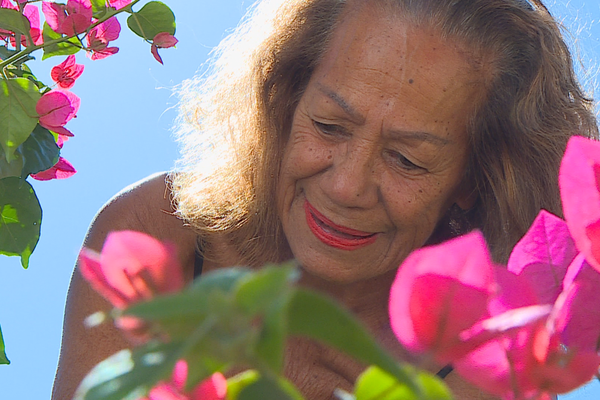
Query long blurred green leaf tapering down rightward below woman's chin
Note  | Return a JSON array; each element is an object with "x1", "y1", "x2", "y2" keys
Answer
[{"x1": 288, "y1": 288, "x2": 419, "y2": 391}]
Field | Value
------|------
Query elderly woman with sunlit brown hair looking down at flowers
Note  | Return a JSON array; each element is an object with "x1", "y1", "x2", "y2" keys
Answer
[{"x1": 54, "y1": 0, "x2": 597, "y2": 399}]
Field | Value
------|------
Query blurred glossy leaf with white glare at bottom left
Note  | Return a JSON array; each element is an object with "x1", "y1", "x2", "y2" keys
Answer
[{"x1": 73, "y1": 343, "x2": 181, "y2": 400}]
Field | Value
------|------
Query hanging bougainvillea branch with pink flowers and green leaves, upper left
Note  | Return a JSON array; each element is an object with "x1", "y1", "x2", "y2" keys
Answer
[{"x1": 0, "y1": 0, "x2": 177, "y2": 268}]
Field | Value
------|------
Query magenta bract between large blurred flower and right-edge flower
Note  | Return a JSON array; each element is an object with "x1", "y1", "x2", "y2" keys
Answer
[{"x1": 507, "y1": 210, "x2": 578, "y2": 304}]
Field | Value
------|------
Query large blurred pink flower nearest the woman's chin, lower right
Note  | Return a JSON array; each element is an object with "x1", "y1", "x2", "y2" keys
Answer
[{"x1": 389, "y1": 232, "x2": 496, "y2": 364}]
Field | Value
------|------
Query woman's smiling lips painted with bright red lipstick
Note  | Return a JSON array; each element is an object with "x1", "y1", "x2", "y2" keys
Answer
[{"x1": 304, "y1": 201, "x2": 377, "y2": 250}]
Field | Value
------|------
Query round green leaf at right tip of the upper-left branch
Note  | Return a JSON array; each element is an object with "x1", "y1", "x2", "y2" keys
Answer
[{"x1": 127, "y1": 1, "x2": 175, "y2": 40}]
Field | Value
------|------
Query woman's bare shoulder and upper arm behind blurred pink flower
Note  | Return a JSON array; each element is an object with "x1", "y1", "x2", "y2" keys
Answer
[{"x1": 52, "y1": 173, "x2": 196, "y2": 400}]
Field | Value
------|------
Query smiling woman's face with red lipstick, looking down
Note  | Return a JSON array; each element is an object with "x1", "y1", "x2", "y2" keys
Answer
[{"x1": 277, "y1": 7, "x2": 481, "y2": 283}]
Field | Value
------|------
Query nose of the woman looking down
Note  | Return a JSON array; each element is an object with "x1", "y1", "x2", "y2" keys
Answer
[{"x1": 323, "y1": 141, "x2": 379, "y2": 208}]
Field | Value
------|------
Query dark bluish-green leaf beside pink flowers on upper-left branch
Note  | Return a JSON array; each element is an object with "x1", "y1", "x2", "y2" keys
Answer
[{"x1": 21, "y1": 124, "x2": 60, "y2": 179}]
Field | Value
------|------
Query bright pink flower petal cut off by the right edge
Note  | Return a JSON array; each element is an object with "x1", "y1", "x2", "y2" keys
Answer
[{"x1": 559, "y1": 136, "x2": 600, "y2": 271}]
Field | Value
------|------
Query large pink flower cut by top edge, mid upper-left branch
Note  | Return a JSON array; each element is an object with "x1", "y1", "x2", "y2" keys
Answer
[{"x1": 42, "y1": 0, "x2": 93, "y2": 36}]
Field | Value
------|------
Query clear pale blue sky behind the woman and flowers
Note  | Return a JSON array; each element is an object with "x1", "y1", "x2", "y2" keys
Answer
[{"x1": 0, "y1": 0, "x2": 600, "y2": 400}]
